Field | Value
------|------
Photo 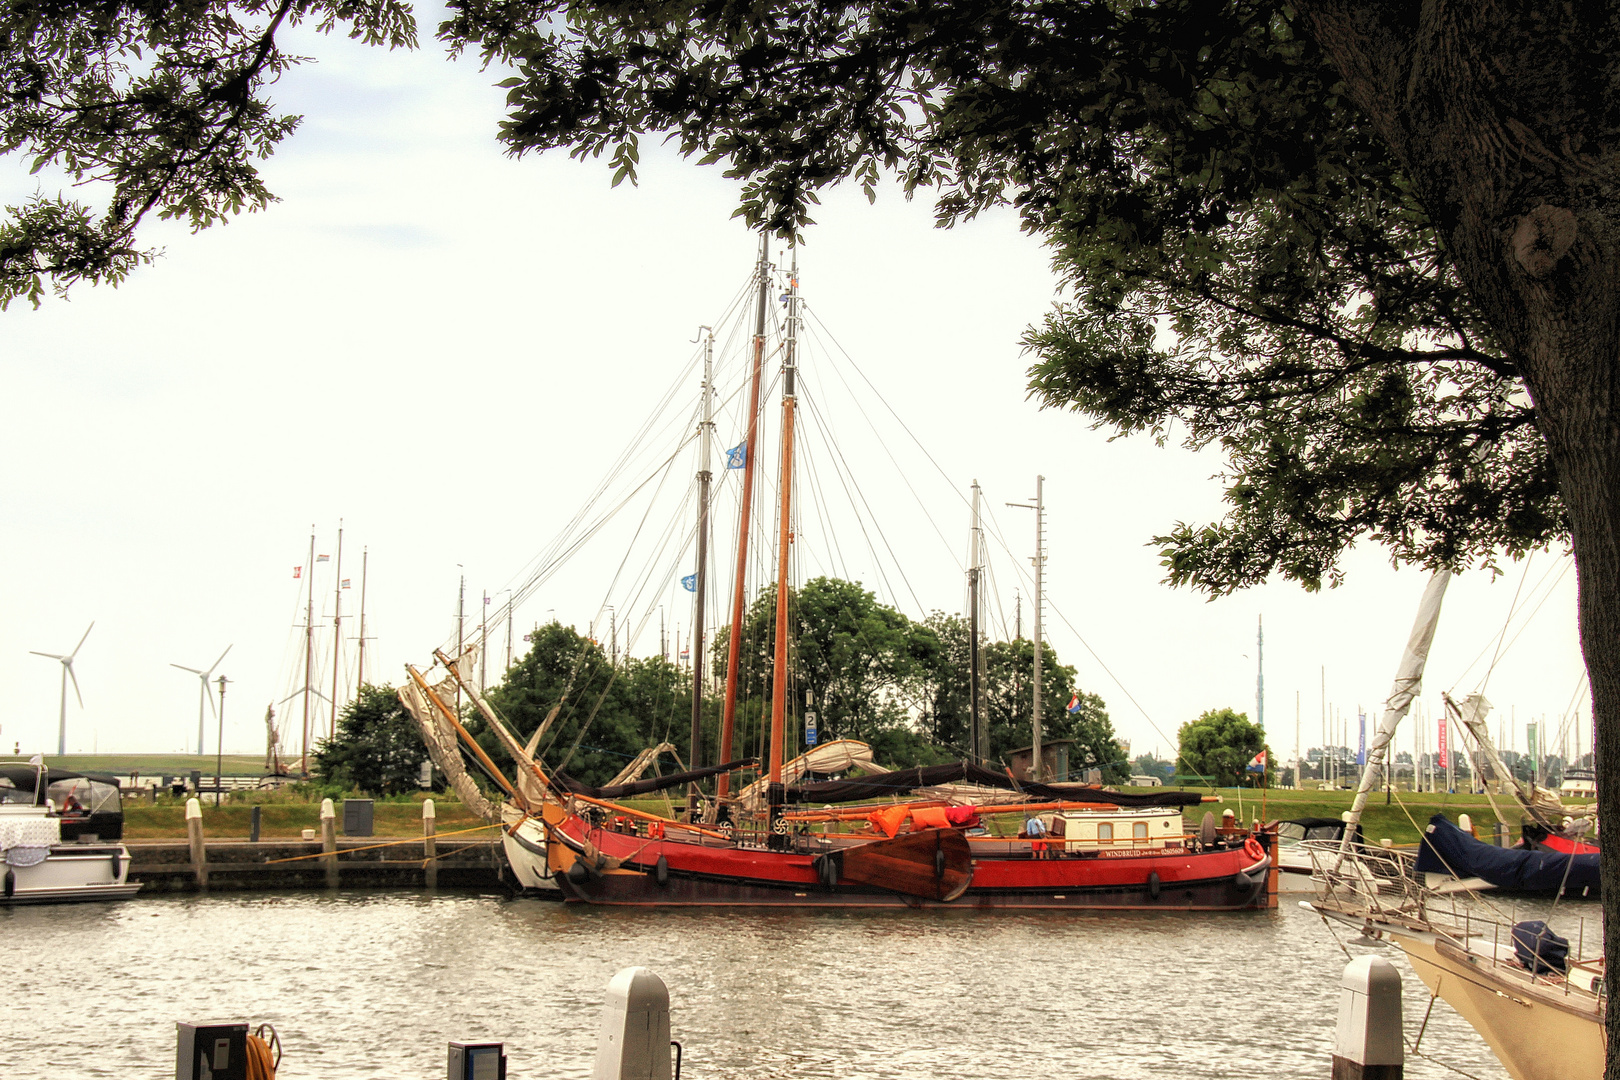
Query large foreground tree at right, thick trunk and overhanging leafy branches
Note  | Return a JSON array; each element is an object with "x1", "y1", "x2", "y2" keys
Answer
[{"x1": 441, "y1": 0, "x2": 1620, "y2": 1042}]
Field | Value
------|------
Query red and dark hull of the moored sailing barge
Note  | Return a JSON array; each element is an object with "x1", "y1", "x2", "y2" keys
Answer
[{"x1": 556, "y1": 814, "x2": 1270, "y2": 910}]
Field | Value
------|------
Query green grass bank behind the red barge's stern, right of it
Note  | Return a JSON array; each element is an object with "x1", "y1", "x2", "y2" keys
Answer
[{"x1": 1153, "y1": 787, "x2": 1518, "y2": 844}]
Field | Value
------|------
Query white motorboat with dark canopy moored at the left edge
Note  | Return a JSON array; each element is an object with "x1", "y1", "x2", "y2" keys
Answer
[{"x1": 0, "y1": 761, "x2": 141, "y2": 904}]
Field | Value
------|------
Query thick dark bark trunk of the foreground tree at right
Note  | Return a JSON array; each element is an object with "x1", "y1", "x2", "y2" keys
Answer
[{"x1": 1299, "y1": 0, "x2": 1620, "y2": 1080}]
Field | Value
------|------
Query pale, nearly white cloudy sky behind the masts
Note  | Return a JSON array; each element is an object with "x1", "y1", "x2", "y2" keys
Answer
[{"x1": 0, "y1": 15, "x2": 1589, "y2": 758}]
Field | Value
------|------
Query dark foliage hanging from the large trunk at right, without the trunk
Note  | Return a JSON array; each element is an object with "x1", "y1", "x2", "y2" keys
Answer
[{"x1": 441, "y1": 0, "x2": 1568, "y2": 593}]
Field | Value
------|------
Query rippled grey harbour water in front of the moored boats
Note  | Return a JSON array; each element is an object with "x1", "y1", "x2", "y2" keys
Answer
[{"x1": 0, "y1": 894, "x2": 1597, "y2": 1080}]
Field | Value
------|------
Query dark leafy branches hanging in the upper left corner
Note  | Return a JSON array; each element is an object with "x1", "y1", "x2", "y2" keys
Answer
[{"x1": 0, "y1": 0, "x2": 416, "y2": 309}]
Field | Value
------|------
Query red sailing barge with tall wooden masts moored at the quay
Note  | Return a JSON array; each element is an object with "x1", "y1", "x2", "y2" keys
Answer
[{"x1": 400, "y1": 238, "x2": 1275, "y2": 910}]
